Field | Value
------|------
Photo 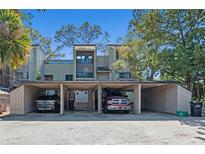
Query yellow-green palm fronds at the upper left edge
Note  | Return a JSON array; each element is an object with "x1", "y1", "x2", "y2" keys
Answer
[{"x1": 0, "y1": 10, "x2": 31, "y2": 69}]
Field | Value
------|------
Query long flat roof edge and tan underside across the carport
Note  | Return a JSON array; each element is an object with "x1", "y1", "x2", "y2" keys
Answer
[{"x1": 21, "y1": 81, "x2": 178, "y2": 90}]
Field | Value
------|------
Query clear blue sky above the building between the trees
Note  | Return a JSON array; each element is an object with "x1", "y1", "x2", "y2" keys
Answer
[{"x1": 23, "y1": 10, "x2": 132, "y2": 59}]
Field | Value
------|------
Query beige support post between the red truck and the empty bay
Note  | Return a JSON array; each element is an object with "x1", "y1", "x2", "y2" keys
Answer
[{"x1": 134, "y1": 84, "x2": 141, "y2": 114}]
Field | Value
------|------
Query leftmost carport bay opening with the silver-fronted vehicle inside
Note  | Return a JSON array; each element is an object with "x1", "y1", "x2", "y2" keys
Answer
[{"x1": 22, "y1": 84, "x2": 60, "y2": 113}]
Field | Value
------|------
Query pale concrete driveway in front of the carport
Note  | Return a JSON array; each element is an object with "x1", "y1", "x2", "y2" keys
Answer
[{"x1": 0, "y1": 112, "x2": 205, "y2": 145}]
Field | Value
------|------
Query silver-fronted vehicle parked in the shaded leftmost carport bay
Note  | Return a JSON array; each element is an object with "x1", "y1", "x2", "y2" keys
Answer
[{"x1": 35, "y1": 94, "x2": 60, "y2": 112}]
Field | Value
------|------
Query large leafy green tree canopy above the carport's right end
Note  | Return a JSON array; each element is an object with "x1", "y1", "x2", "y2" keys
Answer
[{"x1": 124, "y1": 10, "x2": 205, "y2": 95}]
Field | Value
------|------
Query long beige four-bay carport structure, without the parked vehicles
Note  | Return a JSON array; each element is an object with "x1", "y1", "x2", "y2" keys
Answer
[{"x1": 10, "y1": 81, "x2": 191, "y2": 114}]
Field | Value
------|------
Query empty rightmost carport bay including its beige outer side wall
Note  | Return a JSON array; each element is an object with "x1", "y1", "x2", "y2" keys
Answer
[{"x1": 141, "y1": 82, "x2": 192, "y2": 114}]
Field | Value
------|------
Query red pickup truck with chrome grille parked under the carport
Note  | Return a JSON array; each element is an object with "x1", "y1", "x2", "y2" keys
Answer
[{"x1": 103, "y1": 96, "x2": 131, "y2": 113}]
